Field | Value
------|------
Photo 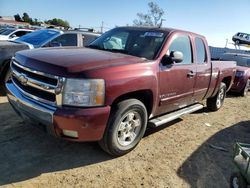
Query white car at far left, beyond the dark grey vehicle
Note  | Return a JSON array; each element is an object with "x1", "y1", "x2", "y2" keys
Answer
[{"x1": 0, "y1": 28, "x2": 33, "y2": 40}]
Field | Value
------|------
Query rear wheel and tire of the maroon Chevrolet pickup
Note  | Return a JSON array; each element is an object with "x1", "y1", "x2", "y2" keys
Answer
[{"x1": 207, "y1": 82, "x2": 227, "y2": 111}]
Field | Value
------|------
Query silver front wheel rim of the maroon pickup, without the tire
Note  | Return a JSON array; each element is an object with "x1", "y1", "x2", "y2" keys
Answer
[{"x1": 117, "y1": 111, "x2": 142, "y2": 146}]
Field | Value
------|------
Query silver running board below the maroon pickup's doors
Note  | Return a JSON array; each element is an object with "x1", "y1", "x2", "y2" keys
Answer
[{"x1": 149, "y1": 104, "x2": 204, "y2": 127}]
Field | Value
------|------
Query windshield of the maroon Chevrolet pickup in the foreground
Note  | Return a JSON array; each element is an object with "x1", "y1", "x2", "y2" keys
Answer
[{"x1": 88, "y1": 28, "x2": 167, "y2": 60}]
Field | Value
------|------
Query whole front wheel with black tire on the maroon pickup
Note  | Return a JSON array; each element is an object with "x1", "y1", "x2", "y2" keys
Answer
[{"x1": 99, "y1": 99, "x2": 148, "y2": 157}]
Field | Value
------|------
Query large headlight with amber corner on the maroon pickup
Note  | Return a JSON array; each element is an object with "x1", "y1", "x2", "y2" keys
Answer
[{"x1": 63, "y1": 79, "x2": 105, "y2": 107}]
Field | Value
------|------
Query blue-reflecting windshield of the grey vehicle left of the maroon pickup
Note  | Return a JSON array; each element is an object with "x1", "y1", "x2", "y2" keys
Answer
[{"x1": 16, "y1": 29, "x2": 60, "y2": 48}]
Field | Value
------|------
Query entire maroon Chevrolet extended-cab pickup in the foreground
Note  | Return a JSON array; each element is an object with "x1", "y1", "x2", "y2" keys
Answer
[{"x1": 6, "y1": 27, "x2": 236, "y2": 156}]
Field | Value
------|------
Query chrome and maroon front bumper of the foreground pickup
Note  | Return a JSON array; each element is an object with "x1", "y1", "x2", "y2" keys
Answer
[{"x1": 6, "y1": 82, "x2": 110, "y2": 141}]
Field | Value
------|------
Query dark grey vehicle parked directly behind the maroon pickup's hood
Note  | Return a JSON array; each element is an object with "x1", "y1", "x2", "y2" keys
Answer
[{"x1": 0, "y1": 29, "x2": 100, "y2": 86}]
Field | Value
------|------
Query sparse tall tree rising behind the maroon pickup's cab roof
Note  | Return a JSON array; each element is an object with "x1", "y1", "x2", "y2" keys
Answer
[{"x1": 133, "y1": 2, "x2": 165, "y2": 27}]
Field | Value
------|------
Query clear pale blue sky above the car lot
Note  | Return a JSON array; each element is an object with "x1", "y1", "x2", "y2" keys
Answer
[{"x1": 0, "y1": 0, "x2": 250, "y2": 47}]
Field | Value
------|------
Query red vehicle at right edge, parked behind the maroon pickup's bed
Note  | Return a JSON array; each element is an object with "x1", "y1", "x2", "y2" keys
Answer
[{"x1": 221, "y1": 53, "x2": 250, "y2": 96}]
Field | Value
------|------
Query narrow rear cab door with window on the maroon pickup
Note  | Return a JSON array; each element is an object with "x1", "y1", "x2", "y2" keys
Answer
[{"x1": 194, "y1": 37, "x2": 211, "y2": 101}]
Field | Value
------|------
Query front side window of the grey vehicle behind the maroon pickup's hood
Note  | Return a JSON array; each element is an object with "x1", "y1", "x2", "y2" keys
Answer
[{"x1": 51, "y1": 34, "x2": 77, "y2": 46}]
